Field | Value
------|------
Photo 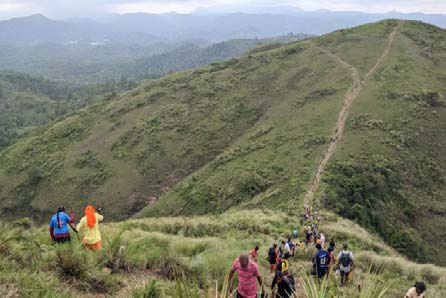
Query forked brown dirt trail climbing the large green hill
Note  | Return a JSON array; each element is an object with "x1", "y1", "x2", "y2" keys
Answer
[{"x1": 305, "y1": 24, "x2": 401, "y2": 210}]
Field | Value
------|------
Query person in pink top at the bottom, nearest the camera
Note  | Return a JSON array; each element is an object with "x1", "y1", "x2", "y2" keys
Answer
[{"x1": 228, "y1": 254, "x2": 263, "y2": 298}]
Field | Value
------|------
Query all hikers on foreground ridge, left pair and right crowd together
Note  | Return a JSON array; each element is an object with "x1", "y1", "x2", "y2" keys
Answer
[{"x1": 50, "y1": 205, "x2": 426, "y2": 298}]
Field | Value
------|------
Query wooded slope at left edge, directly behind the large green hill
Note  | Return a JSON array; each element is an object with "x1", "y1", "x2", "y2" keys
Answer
[{"x1": 0, "y1": 72, "x2": 136, "y2": 150}]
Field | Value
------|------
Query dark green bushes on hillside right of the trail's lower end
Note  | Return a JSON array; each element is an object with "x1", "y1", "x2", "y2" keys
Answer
[{"x1": 325, "y1": 160, "x2": 426, "y2": 259}]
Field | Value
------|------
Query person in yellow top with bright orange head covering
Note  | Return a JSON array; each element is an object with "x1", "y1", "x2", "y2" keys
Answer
[{"x1": 77, "y1": 206, "x2": 104, "y2": 251}]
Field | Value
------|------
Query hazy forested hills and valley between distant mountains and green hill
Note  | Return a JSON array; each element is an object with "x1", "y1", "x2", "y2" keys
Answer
[{"x1": 0, "y1": 34, "x2": 307, "y2": 84}]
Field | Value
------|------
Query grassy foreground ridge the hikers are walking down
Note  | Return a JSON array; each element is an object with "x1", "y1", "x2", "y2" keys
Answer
[{"x1": 0, "y1": 209, "x2": 446, "y2": 298}]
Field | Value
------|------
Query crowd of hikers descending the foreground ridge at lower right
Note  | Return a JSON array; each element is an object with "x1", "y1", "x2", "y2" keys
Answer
[{"x1": 229, "y1": 220, "x2": 426, "y2": 298}]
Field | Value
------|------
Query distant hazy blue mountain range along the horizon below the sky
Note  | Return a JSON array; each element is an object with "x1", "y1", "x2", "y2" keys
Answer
[{"x1": 0, "y1": 7, "x2": 446, "y2": 45}]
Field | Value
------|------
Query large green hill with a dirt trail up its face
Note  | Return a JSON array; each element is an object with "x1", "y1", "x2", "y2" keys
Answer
[{"x1": 0, "y1": 20, "x2": 446, "y2": 264}]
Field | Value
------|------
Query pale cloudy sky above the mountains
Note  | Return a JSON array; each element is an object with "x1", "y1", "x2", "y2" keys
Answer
[{"x1": 0, "y1": 0, "x2": 446, "y2": 19}]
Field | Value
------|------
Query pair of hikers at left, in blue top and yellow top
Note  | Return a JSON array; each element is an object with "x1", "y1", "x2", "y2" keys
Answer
[{"x1": 50, "y1": 205, "x2": 104, "y2": 251}]
